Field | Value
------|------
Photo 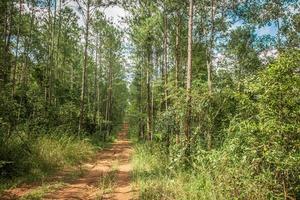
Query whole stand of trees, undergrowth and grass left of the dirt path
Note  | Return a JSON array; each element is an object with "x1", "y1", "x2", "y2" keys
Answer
[{"x1": 0, "y1": 0, "x2": 127, "y2": 188}]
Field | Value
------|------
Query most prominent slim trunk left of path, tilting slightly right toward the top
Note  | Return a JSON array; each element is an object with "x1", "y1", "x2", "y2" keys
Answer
[{"x1": 78, "y1": 0, "x2": 90, "y2": 132}]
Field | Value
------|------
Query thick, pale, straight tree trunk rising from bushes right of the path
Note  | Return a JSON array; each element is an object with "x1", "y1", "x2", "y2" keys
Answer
[{"x1": 185, "y1": 0, "x2": 194, "y2": 145}]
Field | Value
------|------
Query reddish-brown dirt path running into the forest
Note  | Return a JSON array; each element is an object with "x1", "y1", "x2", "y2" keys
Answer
[{"x1": 0, "y1": 125, "x2": 135, "y2": 200}]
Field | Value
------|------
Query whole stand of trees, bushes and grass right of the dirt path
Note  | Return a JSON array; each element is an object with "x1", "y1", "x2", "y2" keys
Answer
[{"x1": 127, "y1": 0, "x2": 300, "y2": 199}]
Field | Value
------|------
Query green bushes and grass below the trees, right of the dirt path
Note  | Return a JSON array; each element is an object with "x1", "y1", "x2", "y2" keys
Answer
[{"x1": 131, "y1": 52, "x2": 300, "y2": 200}]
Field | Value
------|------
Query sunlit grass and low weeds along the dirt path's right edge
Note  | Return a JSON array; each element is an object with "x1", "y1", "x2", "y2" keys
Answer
[{"x1": 133, "y1": 143, "x2": 274, "y2": 200}]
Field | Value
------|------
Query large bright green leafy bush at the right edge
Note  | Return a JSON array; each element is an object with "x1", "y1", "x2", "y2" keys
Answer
[{"x1": 225, "y1": 51, "x2": 300, "y2": 197}]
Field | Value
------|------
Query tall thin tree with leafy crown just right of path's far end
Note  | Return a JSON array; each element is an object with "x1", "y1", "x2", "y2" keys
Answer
[{"x1": 126, "y1": 1, "x2": 165, "y2": 140}]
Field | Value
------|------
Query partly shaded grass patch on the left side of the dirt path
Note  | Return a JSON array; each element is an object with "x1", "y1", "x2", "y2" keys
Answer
[{"x1": 0, "y1": 130, "x2": 108, "y2": 195}]
